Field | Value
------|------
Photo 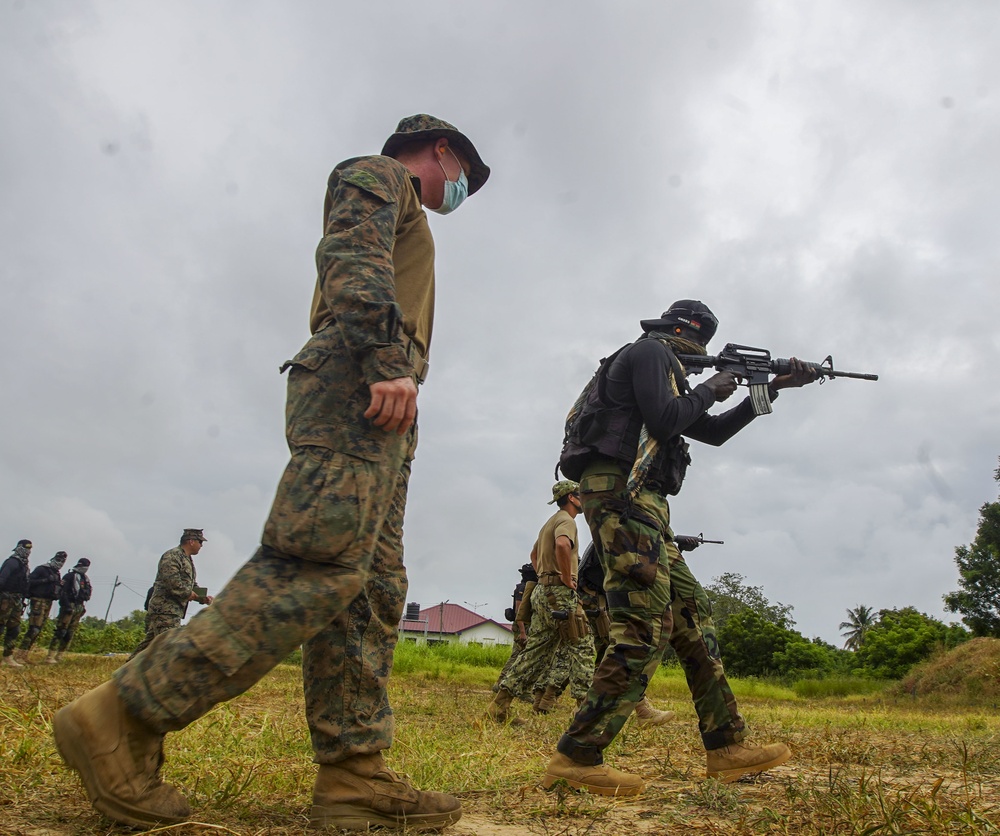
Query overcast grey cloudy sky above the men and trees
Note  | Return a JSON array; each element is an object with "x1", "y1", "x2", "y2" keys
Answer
[{"x1": 0, "y1": 0, "x2": 1000, "y2": 644}]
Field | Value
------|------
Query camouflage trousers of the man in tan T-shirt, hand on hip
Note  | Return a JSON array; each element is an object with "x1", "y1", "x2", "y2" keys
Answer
[{"x1": 498, "y1": 584, "x2": 594, "y2": 702}]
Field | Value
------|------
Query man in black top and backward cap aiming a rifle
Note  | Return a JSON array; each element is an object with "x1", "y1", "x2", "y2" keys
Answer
[{"x1": 542, "y1": 300, "x2": 815, "y2": 795}]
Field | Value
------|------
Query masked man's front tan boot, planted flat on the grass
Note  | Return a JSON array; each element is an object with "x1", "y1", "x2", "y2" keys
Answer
[{"x1": 309, "y1": 752, "x2": 462, "y2": 832}]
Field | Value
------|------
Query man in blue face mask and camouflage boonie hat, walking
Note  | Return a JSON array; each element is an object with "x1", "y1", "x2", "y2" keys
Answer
[{"x1": 53, "y1": 114, "x2": 490, "y2": 830}]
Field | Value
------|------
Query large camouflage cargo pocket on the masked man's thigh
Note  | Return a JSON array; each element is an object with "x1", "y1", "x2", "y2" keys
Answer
[{"x1": 261, "y1": 447, "x2": 373, "y2": 563}]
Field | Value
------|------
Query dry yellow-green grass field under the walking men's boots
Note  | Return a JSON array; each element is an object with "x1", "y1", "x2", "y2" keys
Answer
[{"x1": 0, "y1": 655, "x2": 1000, "y2": 836}]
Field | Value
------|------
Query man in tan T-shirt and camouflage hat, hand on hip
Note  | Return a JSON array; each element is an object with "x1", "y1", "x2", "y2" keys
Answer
[{"x1": 486, "y1": 480, "x2": 594, "y2": 723}]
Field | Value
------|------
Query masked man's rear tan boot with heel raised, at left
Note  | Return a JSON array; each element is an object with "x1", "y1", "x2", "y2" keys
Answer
[{"x1": 52, "y1": 681, "x2": 191, "y2": 827}]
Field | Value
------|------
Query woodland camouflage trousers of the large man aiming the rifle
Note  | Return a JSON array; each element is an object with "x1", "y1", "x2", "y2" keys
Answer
[{"x1": 558, "y1": 462, "x2": 744, "y2": 764}]
